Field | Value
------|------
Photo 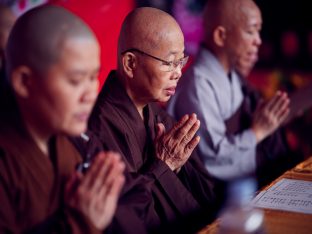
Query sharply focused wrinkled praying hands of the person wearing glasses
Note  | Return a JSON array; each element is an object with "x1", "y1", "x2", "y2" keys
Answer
[{"x1": 155, "y1": 114, "x2": 200, "y2": 172}]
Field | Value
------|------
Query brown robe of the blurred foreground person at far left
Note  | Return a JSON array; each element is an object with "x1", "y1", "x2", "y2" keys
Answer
[{"x1": 0, "y1": 107, "x2": 99, "y2": 233}]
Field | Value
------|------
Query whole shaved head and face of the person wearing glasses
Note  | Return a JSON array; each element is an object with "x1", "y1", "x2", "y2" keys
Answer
[{"x1": 117, "y1": 7, "x2": 185, "y2": 110}]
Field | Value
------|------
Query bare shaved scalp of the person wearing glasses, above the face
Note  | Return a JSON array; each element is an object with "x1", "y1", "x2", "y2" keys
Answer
[{"x1": 118, "y1": 7, "x2": 183, "y2": 61}]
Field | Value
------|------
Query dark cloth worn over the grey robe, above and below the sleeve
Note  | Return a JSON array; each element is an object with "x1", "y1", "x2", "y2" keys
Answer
[{"x1": 226, "y1": 79, "x2": 301, "y2": 187}]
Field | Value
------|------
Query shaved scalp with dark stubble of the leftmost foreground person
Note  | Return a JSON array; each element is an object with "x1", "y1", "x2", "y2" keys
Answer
[{"x1": 6, "y1": 6, "x2": 96, "y2": 77}]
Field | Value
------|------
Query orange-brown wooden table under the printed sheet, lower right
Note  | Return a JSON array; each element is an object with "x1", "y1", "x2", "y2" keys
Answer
[{"x1": 199, "y1": 156, "x2": 312, "y2": 234}]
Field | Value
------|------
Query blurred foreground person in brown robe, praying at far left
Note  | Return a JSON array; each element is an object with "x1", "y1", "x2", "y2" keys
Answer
[{"x1": 0, "y1": 6, "x2": 124, "y2": 233}]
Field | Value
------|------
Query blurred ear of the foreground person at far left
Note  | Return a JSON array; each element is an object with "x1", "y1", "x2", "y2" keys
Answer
[{"x1": 11, "y1": 66, "x2": 33, "y2": 98}]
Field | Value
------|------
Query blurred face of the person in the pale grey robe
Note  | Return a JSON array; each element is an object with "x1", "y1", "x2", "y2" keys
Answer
[{"x1": 226, "y1": 5, "x2": 262, "y2": 72}]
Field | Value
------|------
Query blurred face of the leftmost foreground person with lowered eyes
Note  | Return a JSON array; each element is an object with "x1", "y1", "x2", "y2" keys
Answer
[{"x1": 29, "y1": 38, "x2": 100, "y2": 135}]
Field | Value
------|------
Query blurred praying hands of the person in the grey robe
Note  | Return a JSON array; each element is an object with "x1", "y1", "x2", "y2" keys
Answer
[{"x1": 252, "y1": 91, "x2": 289, "y2": 143}]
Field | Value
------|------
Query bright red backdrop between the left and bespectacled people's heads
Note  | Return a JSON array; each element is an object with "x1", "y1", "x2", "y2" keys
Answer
[{"x1": 51, "y1": 0, "x2": 135, "y2": 87}]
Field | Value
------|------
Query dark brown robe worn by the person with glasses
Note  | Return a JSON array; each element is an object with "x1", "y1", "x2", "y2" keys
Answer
[{"x1": 80, "y1": 71, "x2": 215, "y2": 233}]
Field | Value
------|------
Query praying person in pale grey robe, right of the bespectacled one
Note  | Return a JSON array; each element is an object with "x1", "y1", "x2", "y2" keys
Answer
[{"x1": 168, "y1": 0, "x2": 289, "y2": 185}]
